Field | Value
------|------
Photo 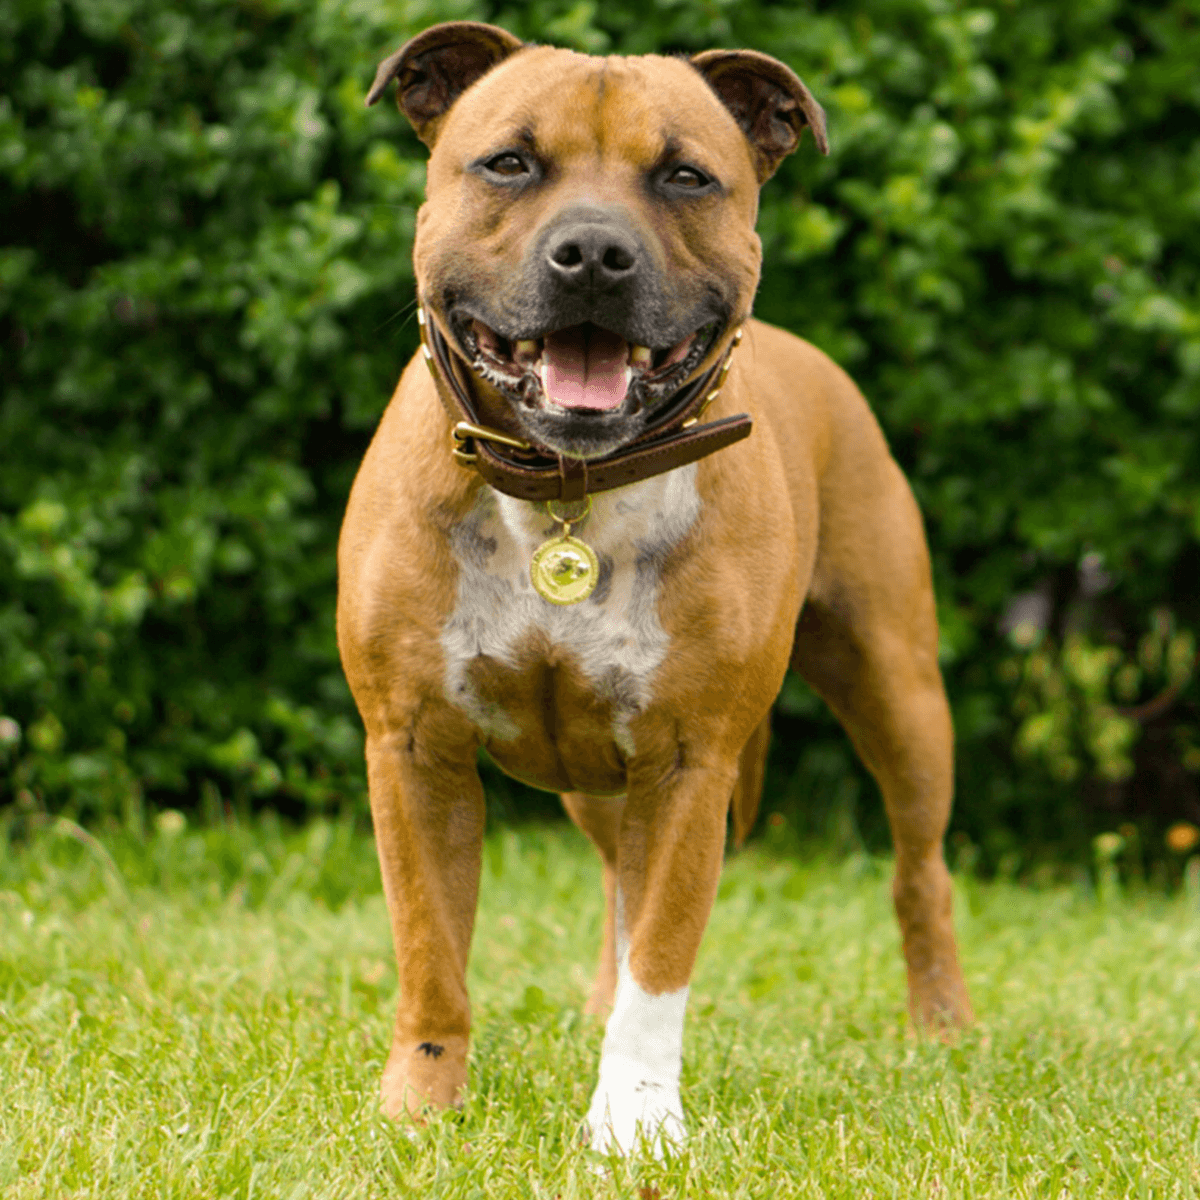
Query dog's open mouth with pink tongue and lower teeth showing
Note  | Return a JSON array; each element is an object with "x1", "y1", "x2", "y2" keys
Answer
[{"x1": 458, "y1": 318, "x2": 720, "y2": 414}]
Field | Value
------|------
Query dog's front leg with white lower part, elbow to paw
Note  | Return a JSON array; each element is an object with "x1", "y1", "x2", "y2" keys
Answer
[{"x1": 587, "y1": 758, "x2": 737, "y2": 1154}]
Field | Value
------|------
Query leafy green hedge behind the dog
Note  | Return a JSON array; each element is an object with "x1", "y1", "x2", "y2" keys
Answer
[{"x1": 0, "y1": 0, "x2": 1200, "y2": 859}]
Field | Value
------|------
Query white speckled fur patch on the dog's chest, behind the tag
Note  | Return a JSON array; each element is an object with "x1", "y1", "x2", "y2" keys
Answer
[{"x1": 442, "y1": 463, "x2": 700, "y2": 755}]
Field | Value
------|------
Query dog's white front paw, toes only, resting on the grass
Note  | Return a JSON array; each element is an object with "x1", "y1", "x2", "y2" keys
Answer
[{"x1": 587, "y1": 1057, "x2": 686, "y2": 1158}]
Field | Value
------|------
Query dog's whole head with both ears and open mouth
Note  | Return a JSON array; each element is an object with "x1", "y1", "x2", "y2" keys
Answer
[{"x1": 367, "y1": 22, "x2": 827, "y2": 458}]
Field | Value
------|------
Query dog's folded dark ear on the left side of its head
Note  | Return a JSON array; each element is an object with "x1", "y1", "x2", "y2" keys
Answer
[{"x1": 367, "y1": 20, "x2": 524, "y2": 150}]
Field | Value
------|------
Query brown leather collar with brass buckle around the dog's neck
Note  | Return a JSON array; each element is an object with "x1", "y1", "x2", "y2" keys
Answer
[{"x1": 416, "y1": 305, "x2": 754, "y2": 500}]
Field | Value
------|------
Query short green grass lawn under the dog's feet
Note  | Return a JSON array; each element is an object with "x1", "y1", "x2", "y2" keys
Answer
[{"x1": 0, "y1": 822, "x2": 1200, "y2": 1200}]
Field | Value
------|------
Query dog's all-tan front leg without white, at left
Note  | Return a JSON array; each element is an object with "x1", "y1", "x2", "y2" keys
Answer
[{"x1": 367, "y1": 730, "x2": 484, "y2": 1117}]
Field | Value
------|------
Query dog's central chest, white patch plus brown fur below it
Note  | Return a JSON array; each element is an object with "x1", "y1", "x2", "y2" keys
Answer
[{"x1": 442, "y1": 466, "x2": 700, "y2": 792}]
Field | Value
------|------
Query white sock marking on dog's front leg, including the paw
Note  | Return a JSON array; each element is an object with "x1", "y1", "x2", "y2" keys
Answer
[{"x1": 587, "y1": 953, "x2": 688, "y2": 1158}]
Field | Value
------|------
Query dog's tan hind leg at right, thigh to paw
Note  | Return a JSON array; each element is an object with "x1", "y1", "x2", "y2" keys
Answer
[{"x1": 792, "y1": 468, "x2": 971, "y2": 1030}]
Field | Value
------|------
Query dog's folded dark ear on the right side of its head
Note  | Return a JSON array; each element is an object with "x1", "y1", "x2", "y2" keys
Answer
[{"x1": 690, "y1": 50, "x2": 829, "y2": 184}]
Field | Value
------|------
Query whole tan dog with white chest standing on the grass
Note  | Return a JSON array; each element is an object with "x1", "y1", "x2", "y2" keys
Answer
[{"x1": 337, "y1": 23, "x2": 971, "y2": 1152}]
